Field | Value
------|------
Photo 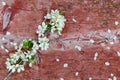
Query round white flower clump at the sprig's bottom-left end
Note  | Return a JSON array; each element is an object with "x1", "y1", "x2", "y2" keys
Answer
[{"x1": 6, "y1": 52, "x2": 27, "y2": 72}]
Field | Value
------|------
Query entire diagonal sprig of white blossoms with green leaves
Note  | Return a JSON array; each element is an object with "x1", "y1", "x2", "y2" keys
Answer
[{"x1": 5, "y1": 10, "x2": 66, "y2": 73}]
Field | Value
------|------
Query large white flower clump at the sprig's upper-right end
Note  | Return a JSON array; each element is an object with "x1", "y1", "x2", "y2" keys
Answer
[{"x1": 44, "y1": 10, "x2": 66, "y2": 35}]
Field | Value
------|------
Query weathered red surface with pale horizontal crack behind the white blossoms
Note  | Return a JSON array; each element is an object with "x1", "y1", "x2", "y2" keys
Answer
[{"x1": 0, "y1": 0, "x2": 120, "y2": 80}]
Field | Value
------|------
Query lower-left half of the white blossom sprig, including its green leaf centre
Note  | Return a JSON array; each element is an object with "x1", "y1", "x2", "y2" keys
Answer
[{"x1": 5, "y1": 39, "x2": 39, "y2": 73}]
